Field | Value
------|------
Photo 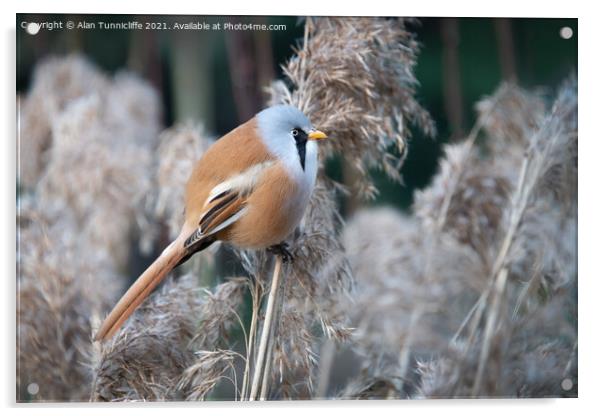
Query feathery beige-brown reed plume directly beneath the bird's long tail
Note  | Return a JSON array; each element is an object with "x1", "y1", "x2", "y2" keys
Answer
[{"x1": 91, "y1": 274, "x2": 246, "y2": 401}]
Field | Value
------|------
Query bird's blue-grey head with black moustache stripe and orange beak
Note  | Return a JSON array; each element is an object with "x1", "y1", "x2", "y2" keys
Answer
[{"x1": 257, "y1": 105, "x2": 327, "y2": 174}]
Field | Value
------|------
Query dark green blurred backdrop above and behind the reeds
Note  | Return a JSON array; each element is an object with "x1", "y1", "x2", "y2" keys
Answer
[{"x1": 17, "y1": 14, "x2": 577, "y2": 211}]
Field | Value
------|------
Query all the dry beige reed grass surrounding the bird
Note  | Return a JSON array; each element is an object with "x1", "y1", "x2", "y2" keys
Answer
[{"x1": 17, "y1": 18, "x2": 577, "y2": 401}]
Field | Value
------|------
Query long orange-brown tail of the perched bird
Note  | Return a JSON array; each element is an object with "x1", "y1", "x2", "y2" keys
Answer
[{"x1": 94, "y1": 237, "x2": 188, "y2": 341}]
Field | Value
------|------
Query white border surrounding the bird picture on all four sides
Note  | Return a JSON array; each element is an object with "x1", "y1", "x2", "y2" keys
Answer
[{"x1": 0, "y1": 0, "x2": 602, "y2": 416}]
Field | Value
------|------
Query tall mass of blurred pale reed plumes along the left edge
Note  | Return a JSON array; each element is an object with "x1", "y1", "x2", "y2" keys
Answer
[{"x1": 17, "y1": 56, "x2": 160, "y2": 400}]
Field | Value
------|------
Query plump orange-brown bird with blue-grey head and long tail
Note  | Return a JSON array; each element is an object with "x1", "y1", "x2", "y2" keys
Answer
[{"x1": 95, "y1": 106, "x2": 326, "y2": 340}]
